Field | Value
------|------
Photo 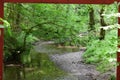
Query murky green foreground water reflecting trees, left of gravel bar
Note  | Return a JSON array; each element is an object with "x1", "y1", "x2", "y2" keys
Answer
[{"x1": 4, "y1": 53, "x2": 65, "y2": 80}]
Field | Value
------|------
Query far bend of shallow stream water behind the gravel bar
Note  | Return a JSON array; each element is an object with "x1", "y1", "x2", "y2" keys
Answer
[{"x1": 34, "y1": 42, "x2": 79, "y2": 54}]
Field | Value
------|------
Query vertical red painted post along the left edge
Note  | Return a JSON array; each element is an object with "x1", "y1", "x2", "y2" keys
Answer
[{"x1": 0, "y1": 0, "x2": 4, "y2": 80}]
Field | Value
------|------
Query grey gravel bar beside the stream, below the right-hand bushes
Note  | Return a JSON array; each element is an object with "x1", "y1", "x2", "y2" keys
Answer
[{"x1": 36, "y1": 41, "x2": 115, "y2": 80}]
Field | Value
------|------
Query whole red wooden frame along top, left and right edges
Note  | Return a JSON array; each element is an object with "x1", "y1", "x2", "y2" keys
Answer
[{"x1": 0, "y1": 0, "x2": 120, "y2": 80}]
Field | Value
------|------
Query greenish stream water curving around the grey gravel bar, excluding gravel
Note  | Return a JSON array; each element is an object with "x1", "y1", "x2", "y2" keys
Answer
[{"x1": 4, "y1": 44, "x2": 79, "y2": 80}]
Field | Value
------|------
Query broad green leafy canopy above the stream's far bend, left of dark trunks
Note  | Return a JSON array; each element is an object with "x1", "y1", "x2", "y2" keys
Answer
[{"x1": 12, "y1": 4, "x2": 88, "y2": 45}]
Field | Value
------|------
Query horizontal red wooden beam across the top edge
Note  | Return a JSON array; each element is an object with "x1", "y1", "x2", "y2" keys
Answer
[{"x1": 4, "y1": 0, "x2": 114, "y2": 4}]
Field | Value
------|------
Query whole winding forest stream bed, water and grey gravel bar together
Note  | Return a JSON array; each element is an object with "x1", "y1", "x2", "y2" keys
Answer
[{"x1": 4, "y1": 42, "x2": 115, "y2": 80}]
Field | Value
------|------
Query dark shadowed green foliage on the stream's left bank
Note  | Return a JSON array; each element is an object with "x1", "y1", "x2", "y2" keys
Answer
[{"x1": 3, "y1": 20, "x2": 37, "y2": 62}]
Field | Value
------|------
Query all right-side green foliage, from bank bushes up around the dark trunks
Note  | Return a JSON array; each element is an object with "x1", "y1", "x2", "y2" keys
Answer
[{"x1": 83, "y1": 4, "x2": 117, "y2": 72}]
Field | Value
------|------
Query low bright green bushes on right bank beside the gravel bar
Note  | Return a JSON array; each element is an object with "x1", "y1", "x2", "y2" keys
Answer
[{"x1": 83, "y1": 30, "x2": 117, "y2": 72}]
